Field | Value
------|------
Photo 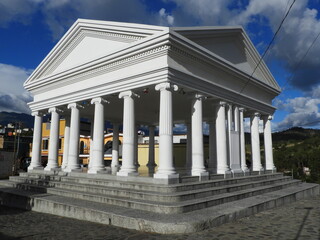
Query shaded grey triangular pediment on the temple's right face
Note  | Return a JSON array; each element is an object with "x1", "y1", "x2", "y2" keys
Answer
[{"x1": 175, "y1": 27, "x2": 280, "y2": 90}]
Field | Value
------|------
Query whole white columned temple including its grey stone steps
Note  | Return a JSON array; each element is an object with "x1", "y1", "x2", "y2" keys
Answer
[{"x1": 0, "y1": 19, "x2": 319, "y2": 234}]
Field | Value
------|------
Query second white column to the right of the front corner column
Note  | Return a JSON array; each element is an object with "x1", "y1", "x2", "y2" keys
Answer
[{"x1": 216, "y1": 102, "x2": 230, "y2": 174}]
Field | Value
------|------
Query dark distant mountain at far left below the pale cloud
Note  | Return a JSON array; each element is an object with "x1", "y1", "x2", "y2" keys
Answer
[{"x1": 0, "y1": 112, "x2": 34, "y2": 128}]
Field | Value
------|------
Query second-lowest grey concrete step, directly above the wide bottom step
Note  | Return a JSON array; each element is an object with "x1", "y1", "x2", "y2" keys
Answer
[{"x1": 47, "y1": 180, "x2": 301, "y2": 214}]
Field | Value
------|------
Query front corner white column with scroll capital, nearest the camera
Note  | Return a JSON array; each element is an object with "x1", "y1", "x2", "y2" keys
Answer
[{"x1": 154, "y1": 83, "x2": 179, "y2": 179}]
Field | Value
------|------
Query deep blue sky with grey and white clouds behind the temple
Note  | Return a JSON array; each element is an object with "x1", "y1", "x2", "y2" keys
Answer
[{"x1": 0, "y1": 0, "x2": 320, "y2": 131}]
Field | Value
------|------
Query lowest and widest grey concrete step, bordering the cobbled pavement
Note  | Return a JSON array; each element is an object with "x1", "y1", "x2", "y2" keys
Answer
[{"x1": 0, "y1": 183, "x2": 319, "y2": 234}]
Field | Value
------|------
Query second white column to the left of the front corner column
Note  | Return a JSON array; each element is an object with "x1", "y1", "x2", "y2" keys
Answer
[{"x1": 88, "y1": 97, "x2": 106, "y2": 173}]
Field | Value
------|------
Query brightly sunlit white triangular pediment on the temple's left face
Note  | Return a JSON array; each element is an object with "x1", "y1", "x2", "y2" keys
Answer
[{"x1": 24, "y1": 19, "x2": 164, "y2": 86}]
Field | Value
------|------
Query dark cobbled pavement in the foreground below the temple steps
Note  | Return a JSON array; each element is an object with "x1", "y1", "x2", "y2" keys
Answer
[{"x1": 0, "y1": 196, "x2": 320, "y2": 240}]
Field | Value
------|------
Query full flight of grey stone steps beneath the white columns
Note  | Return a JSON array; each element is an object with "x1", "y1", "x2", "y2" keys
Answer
[{"x1": 0, "y1": 171, "x2": 319, "y2": 233}]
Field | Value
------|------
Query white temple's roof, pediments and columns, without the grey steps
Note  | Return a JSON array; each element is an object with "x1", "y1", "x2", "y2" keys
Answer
[{"x1": 24, "y1": 19, "x2": 280, "y2": 179}]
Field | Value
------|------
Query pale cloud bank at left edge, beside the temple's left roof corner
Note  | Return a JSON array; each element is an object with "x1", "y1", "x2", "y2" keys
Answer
[{"x1": 0, "y1": 63, "x2": 32, "y2": 113}]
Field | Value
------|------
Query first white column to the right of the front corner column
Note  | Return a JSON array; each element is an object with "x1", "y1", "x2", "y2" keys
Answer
[{"x1": 191, "y1": 94, "x2": 208, "y2": 176}]
